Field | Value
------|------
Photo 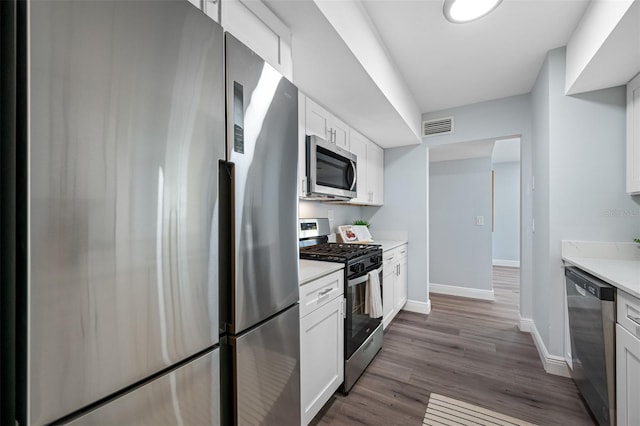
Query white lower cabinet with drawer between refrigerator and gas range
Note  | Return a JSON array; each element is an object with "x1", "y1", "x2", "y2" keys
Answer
[{"x1": 300, "y1": 270, "x2": 345, "y2": 426}]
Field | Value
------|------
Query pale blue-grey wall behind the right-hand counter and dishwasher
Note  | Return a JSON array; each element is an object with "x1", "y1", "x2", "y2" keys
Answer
[{"x1": 532, "y1": 48, "x2": 640, "y2": 357}]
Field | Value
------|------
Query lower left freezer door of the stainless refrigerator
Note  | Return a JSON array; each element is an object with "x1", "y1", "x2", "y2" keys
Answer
[{"x1": 69, "y1": 349, "x2": 220, "y2": 426}]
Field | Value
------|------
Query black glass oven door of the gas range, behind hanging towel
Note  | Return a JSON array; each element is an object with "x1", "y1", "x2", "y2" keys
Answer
[{"x1": 344, "y1": 267, "x2": 384, "y2": 359}]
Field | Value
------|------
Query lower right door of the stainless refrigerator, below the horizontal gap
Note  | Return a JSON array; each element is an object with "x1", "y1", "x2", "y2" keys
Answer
[{"x1": 222, "y1": 304, "x2": 300, "y2": 426}]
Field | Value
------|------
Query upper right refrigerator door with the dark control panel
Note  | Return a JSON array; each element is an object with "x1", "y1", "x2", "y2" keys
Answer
[{"x1": 221, "y1": 33, "x2": 299, "y2": 334}]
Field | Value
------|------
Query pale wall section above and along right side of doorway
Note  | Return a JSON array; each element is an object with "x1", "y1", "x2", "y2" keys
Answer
[{"x1": 422, "y1": 95, "x2": 533, "y2": 318}]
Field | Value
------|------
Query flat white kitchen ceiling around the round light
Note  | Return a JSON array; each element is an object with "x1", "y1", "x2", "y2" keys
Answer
[{"x1": 363, "y1": 0, "x2": 589, "y2": 112}]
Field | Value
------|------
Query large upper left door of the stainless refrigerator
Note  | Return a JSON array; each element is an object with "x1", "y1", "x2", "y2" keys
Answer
[{"x1": 25, "y1": 0, "x2": 225, "y2": 425}]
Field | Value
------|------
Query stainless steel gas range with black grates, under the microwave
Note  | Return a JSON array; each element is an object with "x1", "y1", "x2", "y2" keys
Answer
[{"x1": 300, "y1": 218, "x2": 383, "y2": 395}]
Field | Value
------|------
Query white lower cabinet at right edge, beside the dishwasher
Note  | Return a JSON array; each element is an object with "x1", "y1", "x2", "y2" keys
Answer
[{"x1": 616, "y1": 291, "x2": 640, "y2": 426}]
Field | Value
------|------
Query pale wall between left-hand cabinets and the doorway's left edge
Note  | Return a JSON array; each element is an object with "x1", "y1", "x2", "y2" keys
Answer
[{"x1": 362, "y1": 144, "x2": 429, "y2": 303}]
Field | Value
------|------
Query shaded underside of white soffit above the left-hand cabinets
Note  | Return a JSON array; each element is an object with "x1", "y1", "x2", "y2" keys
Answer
[{"x1": 264, "y1": 0, "x2": 421, "y2": 148}]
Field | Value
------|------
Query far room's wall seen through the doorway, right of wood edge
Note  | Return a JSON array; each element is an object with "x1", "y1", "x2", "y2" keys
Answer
[{"x1": 491, "y1": 161, "x2": 520, "y2": 262}]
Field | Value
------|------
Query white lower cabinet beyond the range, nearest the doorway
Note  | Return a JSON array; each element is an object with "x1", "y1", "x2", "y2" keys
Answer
[{"x1": 382, "y1": 244, "x2": 408, "y2": 328}]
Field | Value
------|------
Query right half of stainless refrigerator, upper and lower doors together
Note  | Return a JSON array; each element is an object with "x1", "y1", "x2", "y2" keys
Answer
[{"x1": 220, "y1": 33, "x2": 300, "y2": 425}]
